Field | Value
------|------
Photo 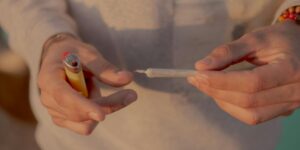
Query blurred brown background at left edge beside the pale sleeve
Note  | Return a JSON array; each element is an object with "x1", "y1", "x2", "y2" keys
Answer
[{"x1": 0, "y1": 29, "x2": 39, "y2": 150}]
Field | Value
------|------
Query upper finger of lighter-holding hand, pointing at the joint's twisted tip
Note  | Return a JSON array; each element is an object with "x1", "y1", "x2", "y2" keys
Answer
[{"x1": 79, "y1": 48, "x2": 132, "y2": 86}]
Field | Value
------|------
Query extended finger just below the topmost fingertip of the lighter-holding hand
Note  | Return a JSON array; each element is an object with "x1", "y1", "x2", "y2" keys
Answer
[{"x1": 96, "y1": 90, "x2": 137, "y2": 114}]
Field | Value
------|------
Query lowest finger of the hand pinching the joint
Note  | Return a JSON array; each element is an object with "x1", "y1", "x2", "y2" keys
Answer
[{"x1": 216, "y1": 101, "x2": 300, "y2": 125}]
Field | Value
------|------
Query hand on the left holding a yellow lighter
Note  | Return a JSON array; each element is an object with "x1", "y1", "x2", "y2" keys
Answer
[{"x1": 38, "y1": 36, "x2": 137, "y2": 135}]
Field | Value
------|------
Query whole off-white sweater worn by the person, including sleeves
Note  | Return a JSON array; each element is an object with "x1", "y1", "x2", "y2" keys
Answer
[{"x1": 0, "y1": 0, "x2": 300, "y2": 150}]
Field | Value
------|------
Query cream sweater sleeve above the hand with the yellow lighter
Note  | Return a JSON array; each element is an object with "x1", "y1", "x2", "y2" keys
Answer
[{"x1": 0, "y1": 0, "x2": 77, "y2": 76}]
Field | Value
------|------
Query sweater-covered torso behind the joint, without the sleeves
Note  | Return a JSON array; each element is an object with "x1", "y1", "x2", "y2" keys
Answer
[{"x1": 32, "y1": 0, "x2": 280, "y2": 150}]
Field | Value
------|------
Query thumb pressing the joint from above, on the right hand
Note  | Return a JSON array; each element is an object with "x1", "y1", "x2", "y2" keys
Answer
[{"x1": 195, "y1": 40, "x2": 253, "y2": 70}]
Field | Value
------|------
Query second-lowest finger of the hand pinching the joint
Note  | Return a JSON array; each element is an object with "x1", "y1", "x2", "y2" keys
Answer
[{"x1": 189, "y1": 83, "x2": 300, "y2": 108}]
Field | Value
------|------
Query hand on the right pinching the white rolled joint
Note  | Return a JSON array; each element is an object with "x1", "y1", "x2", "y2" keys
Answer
[{"x1": 188, "y1": 22, "x2": 300, "y2": 125}]
